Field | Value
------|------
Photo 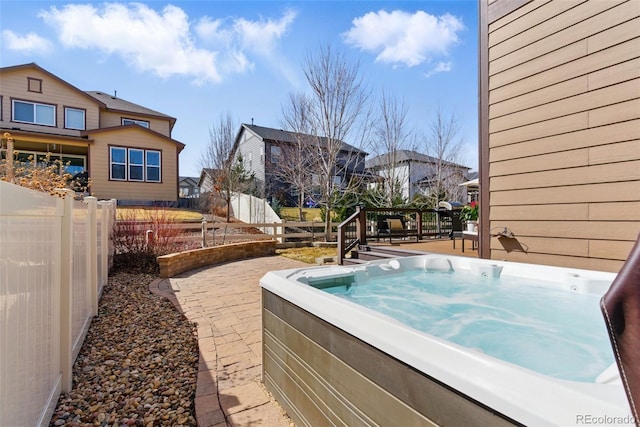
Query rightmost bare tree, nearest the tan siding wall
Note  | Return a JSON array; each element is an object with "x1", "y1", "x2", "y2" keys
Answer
[{"x1": 423, "y1": 106, "x2": 465, "y2": 207}]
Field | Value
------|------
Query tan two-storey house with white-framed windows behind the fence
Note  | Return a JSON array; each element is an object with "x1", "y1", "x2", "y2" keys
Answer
[{"x1": 0, "y1": 63, "x2": 184, "y2": 203}]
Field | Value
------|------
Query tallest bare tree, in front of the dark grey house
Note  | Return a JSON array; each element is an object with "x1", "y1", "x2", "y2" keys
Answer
[{"x1": 284, "y1": 46, "x2": 369, "y2": 240}]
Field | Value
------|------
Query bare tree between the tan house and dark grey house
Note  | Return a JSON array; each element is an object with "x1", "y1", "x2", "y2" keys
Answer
[{"x1": 201, "y1": 113, "x2": 253, "y2": 222}]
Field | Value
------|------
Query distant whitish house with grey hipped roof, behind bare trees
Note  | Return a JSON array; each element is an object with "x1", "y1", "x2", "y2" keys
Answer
[{"x1": 366, "y1": 150, "x2": 470, "y2": 201}]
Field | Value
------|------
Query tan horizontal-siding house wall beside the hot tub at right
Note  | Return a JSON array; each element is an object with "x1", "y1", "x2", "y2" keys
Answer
[{"x1": 479, "y1": 0, "x2": 640, "y2": 272}]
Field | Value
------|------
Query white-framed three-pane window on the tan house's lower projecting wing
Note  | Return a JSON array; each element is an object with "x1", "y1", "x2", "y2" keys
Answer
[{"x1": 109, "y1": 147, "x2": 162, "y2": 182}]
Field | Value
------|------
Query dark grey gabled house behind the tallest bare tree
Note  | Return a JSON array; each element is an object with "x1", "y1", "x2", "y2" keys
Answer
[{"x1": 233, "y1": 124, "x2": 367, "y2": 204}]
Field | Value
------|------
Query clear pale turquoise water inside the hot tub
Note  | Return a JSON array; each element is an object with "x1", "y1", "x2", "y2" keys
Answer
[{"x1": 323, "y1": 270, "x2": 614, "y2": 382}]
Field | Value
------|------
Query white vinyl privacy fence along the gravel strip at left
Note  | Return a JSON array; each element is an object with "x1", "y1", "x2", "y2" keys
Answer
[{"x1": 0, "y1": 182, "x2": 116, "y2": 426}]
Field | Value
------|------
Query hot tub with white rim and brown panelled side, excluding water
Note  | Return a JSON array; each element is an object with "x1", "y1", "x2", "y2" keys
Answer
[{"x1": 260, "y1": 255, "x2": 633, "y2": 426}]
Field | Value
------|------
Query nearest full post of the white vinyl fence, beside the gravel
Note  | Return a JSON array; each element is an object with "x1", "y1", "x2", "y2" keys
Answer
[{"x1": 60, "y1": 189, "x2": 73, "y2": 393}]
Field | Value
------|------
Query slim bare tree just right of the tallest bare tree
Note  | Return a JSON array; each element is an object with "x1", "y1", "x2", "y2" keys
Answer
[{"x1": 374, "y1": 90, "x2": 413, "y2": 206}]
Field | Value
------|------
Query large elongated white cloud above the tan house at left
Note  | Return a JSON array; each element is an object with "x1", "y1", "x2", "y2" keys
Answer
[{"x1": 40, "y1": 3, "x2": 295, "y2": 83}]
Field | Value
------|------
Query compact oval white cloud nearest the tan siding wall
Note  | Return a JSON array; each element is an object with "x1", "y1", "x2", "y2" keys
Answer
[{"x1": 343, "y1": 10, "x2": 464, "y2": 67}]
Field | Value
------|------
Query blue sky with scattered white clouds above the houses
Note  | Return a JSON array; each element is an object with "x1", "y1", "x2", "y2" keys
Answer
[{"x1": 0, "y1": 0, "x2": 478, "y2": 176}]
